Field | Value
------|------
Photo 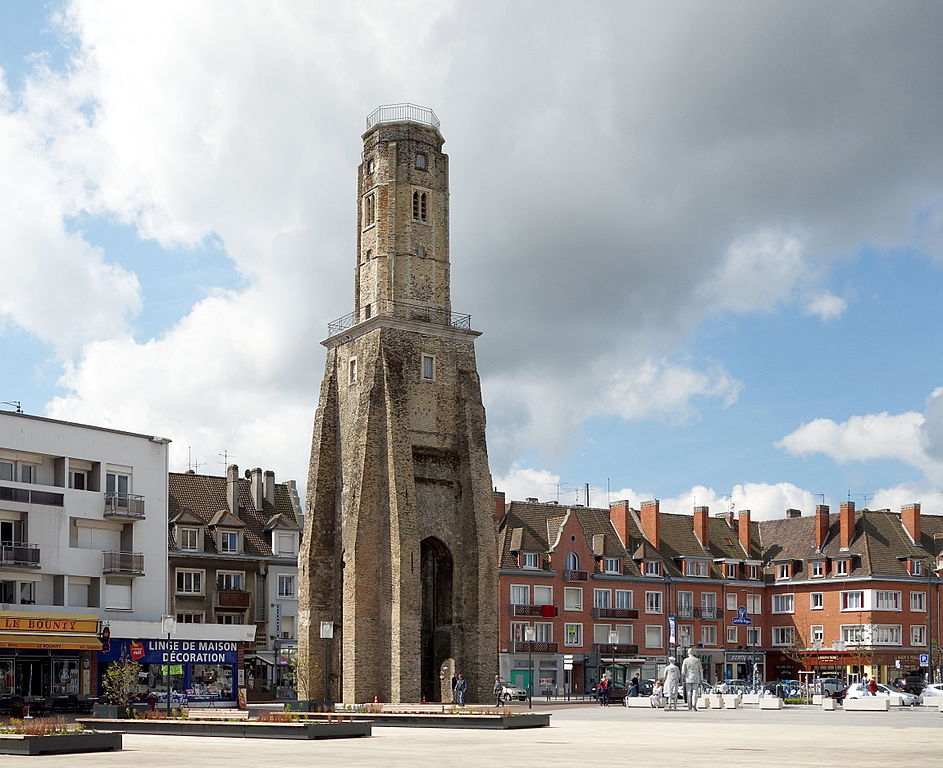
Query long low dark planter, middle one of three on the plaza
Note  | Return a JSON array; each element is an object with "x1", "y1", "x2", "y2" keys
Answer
[{"x1": 78, "y1": 719, "x2": 372, "y2": 741}]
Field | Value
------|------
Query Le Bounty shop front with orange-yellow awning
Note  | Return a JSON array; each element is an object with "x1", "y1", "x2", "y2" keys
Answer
[{"x1": 0, "y1": 612, "x2": 101, "y2": 711}]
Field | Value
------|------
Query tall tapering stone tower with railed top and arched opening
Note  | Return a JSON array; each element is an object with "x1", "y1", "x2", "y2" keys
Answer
[{"x1": 298, "y1": 105, "x2": 498, "y2": 703}]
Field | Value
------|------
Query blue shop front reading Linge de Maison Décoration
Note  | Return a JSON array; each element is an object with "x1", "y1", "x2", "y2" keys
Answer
[{"x1": 98, "y1": 639, "x2": 239, "y2": 705}]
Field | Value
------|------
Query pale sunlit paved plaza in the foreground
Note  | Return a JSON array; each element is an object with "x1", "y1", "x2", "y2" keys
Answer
[{"x1": 9, "y1": 705, "x2": 943, "y2": 768}]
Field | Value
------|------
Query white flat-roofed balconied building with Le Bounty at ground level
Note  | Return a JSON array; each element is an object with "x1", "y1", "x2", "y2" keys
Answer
[{"x1": 0, "y1": 412, "x2": 169, "y2": 702}]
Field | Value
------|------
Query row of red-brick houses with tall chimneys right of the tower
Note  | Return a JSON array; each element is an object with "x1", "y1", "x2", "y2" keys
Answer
[{"x1": 495, "y1": 492, "x2": 943, "y2": 695}]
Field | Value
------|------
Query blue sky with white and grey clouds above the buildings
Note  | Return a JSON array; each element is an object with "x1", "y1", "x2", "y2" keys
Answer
[{"x1": 0, "y1": 0, "x2": 943, "y2": 519}]
